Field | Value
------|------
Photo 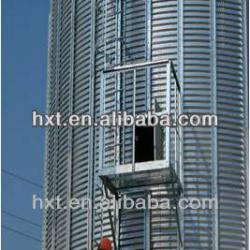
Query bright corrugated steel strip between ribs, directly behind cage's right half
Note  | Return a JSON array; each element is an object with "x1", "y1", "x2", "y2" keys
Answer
[{"x1": 151, "y1": 0, "x2": 178, "y2": 250}]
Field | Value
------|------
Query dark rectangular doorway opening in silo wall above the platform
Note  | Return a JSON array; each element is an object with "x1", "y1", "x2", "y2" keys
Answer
[{"x1": 135, "y1": 127, "x2": 154, "y2": 162}]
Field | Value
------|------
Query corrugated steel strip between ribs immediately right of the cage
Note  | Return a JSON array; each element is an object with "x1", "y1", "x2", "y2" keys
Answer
[{"x1": 183, "y1": 0, "x2": 215, "y2": 250}]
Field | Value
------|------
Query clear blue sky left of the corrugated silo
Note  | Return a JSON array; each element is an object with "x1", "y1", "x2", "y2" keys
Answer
[{"x1": 2, "y1": 0, "x2": 49, "y2": 250}]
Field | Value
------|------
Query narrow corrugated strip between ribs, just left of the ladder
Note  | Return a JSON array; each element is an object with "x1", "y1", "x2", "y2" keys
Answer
[{"x1": 70, "y1": 0, "x2": 91, "y2": 250}]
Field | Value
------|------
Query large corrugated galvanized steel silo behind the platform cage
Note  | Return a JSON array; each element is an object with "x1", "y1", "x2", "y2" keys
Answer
[{"x1": 44, "y1": 0, "x2": 248, "y2": 250}]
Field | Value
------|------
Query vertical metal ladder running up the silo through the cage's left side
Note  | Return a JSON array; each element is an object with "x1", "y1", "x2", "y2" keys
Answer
[{"x1": 95, "y1": 0, "x2": 122, "y2": 250}]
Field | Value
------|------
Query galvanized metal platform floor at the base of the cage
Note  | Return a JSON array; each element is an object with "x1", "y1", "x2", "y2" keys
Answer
[{"x1": 99, "y1": 160, "x2": 181, "y2": 194}]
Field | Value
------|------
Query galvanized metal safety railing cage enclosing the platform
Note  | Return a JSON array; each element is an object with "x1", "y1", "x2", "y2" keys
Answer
[{"x1": 99, "y1": 60, "x2": 182, "y2": 177}]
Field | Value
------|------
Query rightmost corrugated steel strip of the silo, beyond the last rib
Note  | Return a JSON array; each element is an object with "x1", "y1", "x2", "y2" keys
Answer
[{"x1": 216, "y1": 0, "x2": 247, "y2": 250}]
